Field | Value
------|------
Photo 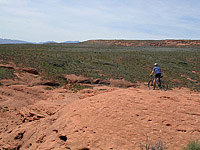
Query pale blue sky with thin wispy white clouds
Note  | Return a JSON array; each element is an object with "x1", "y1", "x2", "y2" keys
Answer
[{"x1": 0, "y1": 0, "x2": 200, "y2": 42}]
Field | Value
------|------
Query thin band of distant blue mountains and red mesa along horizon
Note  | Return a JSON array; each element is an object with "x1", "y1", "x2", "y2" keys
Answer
[{"x1": 0, "y1": 38, "x2": 200, "y2": 47}]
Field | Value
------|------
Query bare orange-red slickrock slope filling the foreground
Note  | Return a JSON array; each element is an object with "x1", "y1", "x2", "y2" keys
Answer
[{"x1": 0, "y1": 68, "x2": 200, "y2": 150}]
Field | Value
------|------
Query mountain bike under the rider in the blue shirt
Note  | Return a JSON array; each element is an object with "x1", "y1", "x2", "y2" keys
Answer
[{"x1": 148, "y1": 76, "x2": 168, "y2": 91}]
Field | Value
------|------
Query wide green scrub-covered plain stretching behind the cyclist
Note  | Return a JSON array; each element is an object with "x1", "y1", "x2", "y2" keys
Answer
[{"x1": 0, "y1": 43, "x2": 200, "y2": 90}]
